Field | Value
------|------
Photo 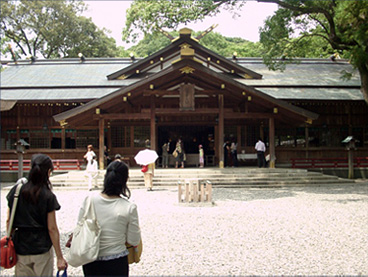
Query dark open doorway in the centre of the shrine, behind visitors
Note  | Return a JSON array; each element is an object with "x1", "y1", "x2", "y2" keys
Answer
[{"x1": 158, "y1": 126, "x2": 215, "y2": 155}]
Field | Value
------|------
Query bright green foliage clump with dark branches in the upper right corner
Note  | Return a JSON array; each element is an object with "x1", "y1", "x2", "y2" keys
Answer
[{"x1": 261, "y1": 0, "x2": 368, "y2": 103}]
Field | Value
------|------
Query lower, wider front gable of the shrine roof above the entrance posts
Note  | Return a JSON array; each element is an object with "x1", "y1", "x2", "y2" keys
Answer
[{"x1": 54, "y1": 57, "x2": 318, "y2": 125}]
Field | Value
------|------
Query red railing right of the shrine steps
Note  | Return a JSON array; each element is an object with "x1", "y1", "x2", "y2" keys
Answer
[{"x1": 291, "y1": 157, "x2": 368, "y2": 168}]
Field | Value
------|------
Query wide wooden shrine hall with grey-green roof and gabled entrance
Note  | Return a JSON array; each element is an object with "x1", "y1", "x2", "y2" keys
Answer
[{"x1": 1, "y1": 28, "x2": 368, "y2": 168}]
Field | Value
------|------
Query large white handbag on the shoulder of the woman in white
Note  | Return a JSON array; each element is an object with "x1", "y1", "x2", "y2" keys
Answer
[{"x1": 66, "y1": 193, "x2": 101, "y2": 267}]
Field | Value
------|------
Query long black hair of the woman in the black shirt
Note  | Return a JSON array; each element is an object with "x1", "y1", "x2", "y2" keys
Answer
[{"x1": 22, "y1": 154, "x2": 54, "y2": 204}]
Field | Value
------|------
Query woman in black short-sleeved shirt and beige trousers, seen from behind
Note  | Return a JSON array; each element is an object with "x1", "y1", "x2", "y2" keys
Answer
[{"x1": 6, "y1": 154, "x2": 68, "y2": 276}]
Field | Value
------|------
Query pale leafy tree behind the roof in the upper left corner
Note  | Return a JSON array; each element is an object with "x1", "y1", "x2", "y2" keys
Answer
[{"x1": 0, "y1": 0, "x2": 117, "y2": 58}]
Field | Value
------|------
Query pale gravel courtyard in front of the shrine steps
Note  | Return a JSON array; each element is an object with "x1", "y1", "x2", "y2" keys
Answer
[{"x1": 0, "y1": 183, "x2": 368, "y2": 276}]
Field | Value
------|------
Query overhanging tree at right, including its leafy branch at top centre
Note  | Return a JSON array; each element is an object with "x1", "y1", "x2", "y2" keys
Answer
[{"x1": 123, "y1": 0, "x2": 368, "y2": 103}]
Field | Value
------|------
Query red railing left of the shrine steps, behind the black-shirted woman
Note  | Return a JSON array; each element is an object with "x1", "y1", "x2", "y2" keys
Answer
[{"x1": 0, "y1": 159, "x2": 84, "y2": 171}]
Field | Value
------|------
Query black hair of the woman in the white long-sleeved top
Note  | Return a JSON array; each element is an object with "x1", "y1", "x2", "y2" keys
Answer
[{"x1": 102, "y1": 161, "x2": 131, "y2": 198}]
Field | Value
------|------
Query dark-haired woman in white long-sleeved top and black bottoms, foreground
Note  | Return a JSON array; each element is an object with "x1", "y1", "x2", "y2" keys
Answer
[{"x1": 81, "y1": 161, "x2": 141, "y2": 276}]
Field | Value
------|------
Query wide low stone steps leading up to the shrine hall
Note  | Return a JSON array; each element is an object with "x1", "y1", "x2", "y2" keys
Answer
[{"x1": 51, "y1": 168, "x2": 354, "y2": 187}]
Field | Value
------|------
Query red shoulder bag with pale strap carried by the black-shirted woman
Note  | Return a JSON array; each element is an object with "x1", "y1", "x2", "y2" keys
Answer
[{"x1": 0, "y1": 178, "x2": 27, "y2": 268}]
